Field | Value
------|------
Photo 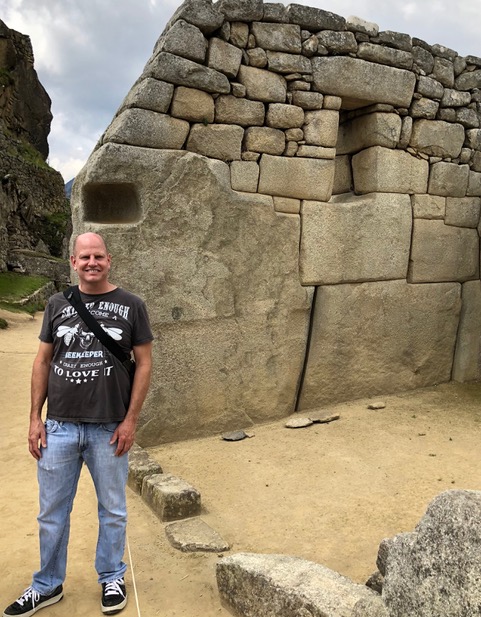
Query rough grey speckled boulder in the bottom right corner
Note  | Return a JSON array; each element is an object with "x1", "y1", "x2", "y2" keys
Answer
[{"x1": 382, "y1": 490, "x2": 481, "y2": 617}]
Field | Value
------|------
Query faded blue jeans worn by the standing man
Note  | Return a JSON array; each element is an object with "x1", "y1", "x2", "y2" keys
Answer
[{"x1": 32, "y1": 420, "x2": 128, "y2": 594}]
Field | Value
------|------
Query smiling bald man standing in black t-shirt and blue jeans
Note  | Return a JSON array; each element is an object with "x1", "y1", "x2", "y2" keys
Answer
[{"x1": 3, "y1": 233, "x2": 153, "y2": 617}]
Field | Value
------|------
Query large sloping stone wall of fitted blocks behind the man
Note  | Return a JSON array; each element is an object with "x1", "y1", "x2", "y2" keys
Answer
[{"x1": 72, "y1": 0, "x2": 481, "y2": 445}]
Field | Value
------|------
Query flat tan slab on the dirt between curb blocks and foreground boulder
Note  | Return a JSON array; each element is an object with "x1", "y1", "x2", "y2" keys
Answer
[{"x1": 165, "y1": 517, "x2": 229, "y2": 553}]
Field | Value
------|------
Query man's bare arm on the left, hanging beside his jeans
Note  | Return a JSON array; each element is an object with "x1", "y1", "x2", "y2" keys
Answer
[{"x1": 28, "y1": 342, "x2": 53, "y2": 461}]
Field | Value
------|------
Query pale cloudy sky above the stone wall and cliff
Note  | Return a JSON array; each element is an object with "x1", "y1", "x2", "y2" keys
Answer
[{"x1": 0, "y1": 0, "x2": 481, "y2": 182}]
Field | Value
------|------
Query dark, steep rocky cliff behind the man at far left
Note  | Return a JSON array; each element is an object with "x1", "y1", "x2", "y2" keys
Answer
[{"x1": 0, "y1": 21, "x2": 71, "y2": 283}]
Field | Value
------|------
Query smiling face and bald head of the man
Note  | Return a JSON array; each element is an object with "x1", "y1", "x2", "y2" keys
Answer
[{"x1": 70, "y1": 234, "x2": 110, "y2": 285}]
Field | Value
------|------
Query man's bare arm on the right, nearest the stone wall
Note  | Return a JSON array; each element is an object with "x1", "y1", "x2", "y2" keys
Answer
[{"x1": 110, "y1": 342, "x2": 152, "y2": 456}]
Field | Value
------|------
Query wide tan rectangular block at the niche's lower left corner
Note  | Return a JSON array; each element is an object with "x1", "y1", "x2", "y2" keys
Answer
[{"x1": 259, "y1": 154, "x2": 334, "y2": 201}]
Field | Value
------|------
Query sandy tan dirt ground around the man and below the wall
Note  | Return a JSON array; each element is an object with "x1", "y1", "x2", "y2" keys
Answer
[{"x1": 0, "y1": 314, "x2": 481, "y2": 617}]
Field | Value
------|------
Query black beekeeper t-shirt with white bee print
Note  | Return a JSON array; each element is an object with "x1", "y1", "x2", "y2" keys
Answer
[{"x1": 39, "y1": 287, "x2": 153, "y2": 422}]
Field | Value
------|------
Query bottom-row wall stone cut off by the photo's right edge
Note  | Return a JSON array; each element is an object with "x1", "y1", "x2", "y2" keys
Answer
[{"x1": 453, "y1": 281, "x2": 481, "y2": 382}]
